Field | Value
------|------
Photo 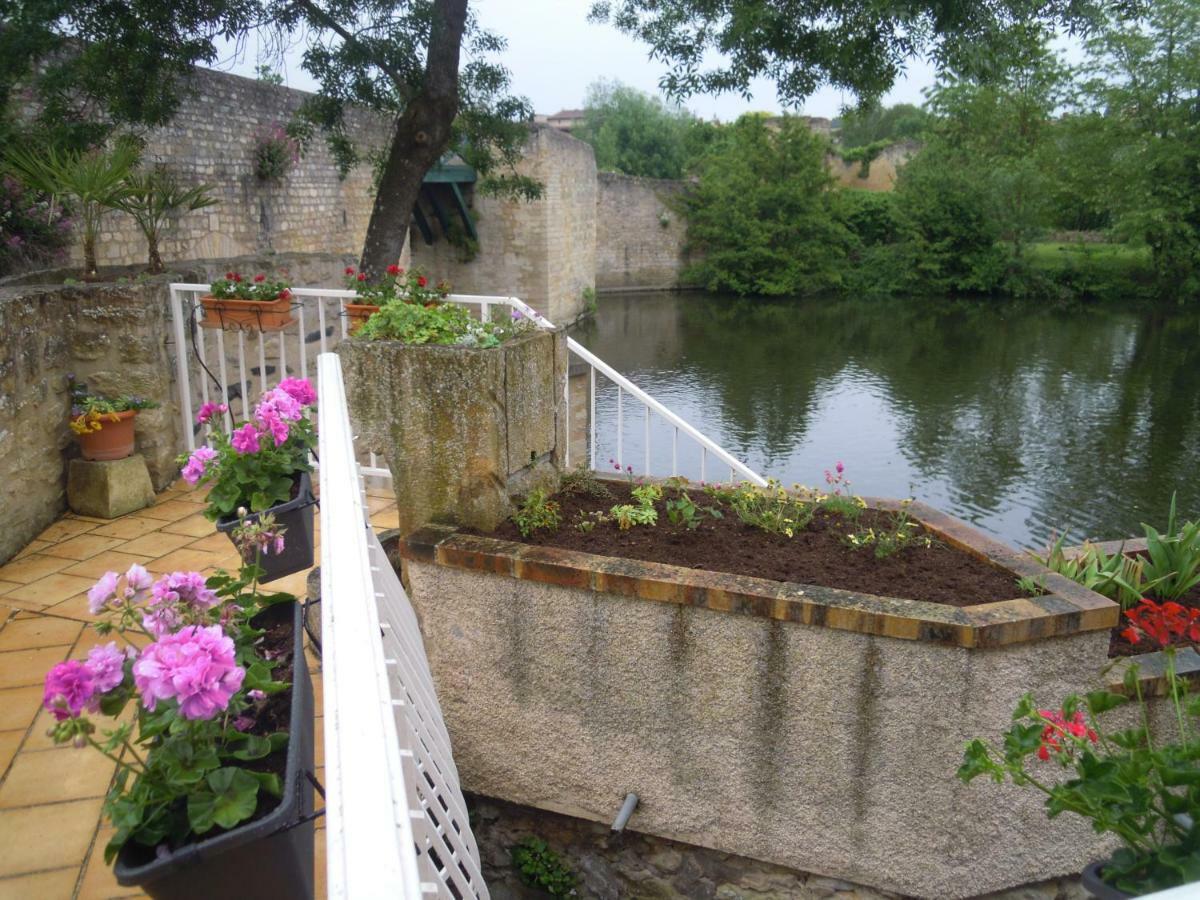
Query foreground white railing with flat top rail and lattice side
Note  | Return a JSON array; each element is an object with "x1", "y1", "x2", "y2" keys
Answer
[{"x1": 317, "y1": 353, "x2": 490, "y2": 900}]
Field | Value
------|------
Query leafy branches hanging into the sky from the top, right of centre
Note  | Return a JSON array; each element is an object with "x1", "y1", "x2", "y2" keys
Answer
[{"x1": 590, "y1": 0, "x2": 1103, "y2": 106}]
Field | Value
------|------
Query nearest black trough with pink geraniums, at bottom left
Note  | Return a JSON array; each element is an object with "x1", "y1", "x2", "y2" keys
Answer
[{"x1": 43, "y1": 517, "x2": 313, "y2": 900}]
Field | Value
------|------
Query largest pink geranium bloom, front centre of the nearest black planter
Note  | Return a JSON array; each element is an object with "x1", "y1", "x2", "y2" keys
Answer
[{"x1": 133, "y1": 625, "x2": 246, "y2": 719}]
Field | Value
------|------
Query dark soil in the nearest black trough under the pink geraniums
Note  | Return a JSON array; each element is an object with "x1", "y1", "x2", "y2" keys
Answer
[{"x1": 116, "y1": 604, "x2": 295, "y2": 866}]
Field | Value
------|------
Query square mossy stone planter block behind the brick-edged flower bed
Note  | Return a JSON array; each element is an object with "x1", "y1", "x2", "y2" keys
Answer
[{"x1": 337, "y1": 331, "x2": 566, "y2": 533}]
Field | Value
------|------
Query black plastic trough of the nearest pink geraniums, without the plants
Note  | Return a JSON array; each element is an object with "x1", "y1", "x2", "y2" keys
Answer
[{"x1": 113, "y1": 604, "x2": 313, "y2": 900}]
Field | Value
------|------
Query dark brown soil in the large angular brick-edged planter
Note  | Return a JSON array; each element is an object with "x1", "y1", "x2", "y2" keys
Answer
[{"x1": 477, "y1": 482, "x2": 1021, "y2": 606}]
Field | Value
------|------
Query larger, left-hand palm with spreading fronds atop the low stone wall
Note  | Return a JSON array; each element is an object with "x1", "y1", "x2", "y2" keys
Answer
[{"x1": 4, "y1": 142, "x2": 138, "y2": 278}]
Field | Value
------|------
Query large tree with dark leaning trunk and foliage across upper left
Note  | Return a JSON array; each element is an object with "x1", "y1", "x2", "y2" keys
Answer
[{"x1": 0, "y1": 0, "x2": 539, "y2": 274}]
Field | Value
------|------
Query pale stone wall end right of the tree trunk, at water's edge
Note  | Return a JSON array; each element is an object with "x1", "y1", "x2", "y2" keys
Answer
[{"x1": 410, "y1": 126, "x2": 596, "y2": 325}]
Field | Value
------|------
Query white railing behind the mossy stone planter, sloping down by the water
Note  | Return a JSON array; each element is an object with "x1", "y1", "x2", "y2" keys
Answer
[{"x1": 170, "y1": 283, "x2": 767, "y2": 485}]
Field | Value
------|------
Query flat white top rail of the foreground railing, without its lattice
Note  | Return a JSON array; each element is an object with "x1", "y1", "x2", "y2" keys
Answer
[{"x1": 317, "y1": 353, "x2": 421, "y2": 900}]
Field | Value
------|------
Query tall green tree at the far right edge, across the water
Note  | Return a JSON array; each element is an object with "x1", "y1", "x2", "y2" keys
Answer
[{"x1": 1082, "y1": 0, "x2": 1200, "y2": 299}]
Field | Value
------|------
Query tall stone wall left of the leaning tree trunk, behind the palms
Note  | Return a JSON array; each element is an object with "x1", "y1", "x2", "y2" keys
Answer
[{"x1": 72, "y1": 68, "x2": 390, "y2": 265}]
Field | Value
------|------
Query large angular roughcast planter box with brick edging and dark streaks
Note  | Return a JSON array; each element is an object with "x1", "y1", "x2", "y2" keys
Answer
[{"x1": 397, "y1": 504, "x2": 1200, "y2": 898}]
